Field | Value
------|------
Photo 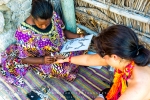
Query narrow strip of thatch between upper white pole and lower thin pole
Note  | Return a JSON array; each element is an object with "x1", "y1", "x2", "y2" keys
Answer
[{"x1": 76, "y1": 7, "x2": 150, "y2": 35}]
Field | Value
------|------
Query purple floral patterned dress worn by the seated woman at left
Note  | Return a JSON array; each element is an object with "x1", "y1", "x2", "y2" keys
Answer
[{"x1": 1, "y1": 12, "x2": 84, "y2": 86}]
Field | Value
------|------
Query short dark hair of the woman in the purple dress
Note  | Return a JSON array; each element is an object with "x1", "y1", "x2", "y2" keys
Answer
[{"x1": 31, "y1": 0, "x2": 53, "y2": 19}]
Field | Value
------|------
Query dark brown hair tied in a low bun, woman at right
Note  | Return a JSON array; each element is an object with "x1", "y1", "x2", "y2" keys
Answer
[{"x1": 95, "y1": 25, "x2": 150, "y2": 66}]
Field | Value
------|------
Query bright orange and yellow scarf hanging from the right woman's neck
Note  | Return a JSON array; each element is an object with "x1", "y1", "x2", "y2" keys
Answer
[{"x1": 106, "y1": 61, "x2": 134, "y2": 100}]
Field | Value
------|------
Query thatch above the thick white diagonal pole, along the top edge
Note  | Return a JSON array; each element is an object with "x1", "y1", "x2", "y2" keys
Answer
[{"x1": 74, "y1": 0, "x2": 150, "y2": 16}]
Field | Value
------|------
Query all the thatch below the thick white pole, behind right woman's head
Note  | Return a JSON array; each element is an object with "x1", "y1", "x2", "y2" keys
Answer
[{"x1": 76, "y1": 7, "x2": 150, "y2": 49}]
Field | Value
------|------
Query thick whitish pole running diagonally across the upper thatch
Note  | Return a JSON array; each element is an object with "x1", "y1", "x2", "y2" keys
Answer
[{"x1": 81, "y1": 0, "x2": 150, "y2": 24}]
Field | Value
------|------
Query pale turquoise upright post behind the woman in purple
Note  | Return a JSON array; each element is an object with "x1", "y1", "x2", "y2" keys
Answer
[{"x1": 61, "y1": 0, "x2": 77, "y2": 33}]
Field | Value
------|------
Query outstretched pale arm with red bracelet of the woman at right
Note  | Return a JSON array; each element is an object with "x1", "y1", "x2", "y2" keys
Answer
[{"x1": 56, "y1": 54, "x2": 108, "y2": 66}]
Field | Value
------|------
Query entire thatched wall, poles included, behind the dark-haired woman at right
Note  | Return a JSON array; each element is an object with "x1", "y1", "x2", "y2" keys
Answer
[{"x1": 74, "y1": 0, "x2": 150, "y2": 49}]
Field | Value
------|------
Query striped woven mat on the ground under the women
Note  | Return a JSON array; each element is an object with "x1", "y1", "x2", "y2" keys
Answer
[{"x1": 0, "y1": 67, "x2": 110, "y2": 100}]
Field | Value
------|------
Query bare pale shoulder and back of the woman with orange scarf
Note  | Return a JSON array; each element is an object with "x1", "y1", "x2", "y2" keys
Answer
[{"x1": 119, "y1": 66, "x2": 150, "y2": 100}]
